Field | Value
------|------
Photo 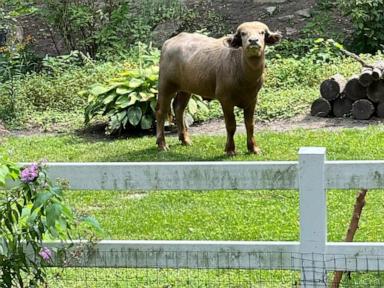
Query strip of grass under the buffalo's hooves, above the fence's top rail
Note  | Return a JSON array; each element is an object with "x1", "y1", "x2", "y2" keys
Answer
[{"x1": 0, "y1": 125, "x2": 384, "y2": 162}]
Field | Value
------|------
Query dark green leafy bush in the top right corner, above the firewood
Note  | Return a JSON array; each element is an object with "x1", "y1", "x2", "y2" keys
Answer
[{"x1": 338, "y1": 0, "x2": 384, "y2": 53}]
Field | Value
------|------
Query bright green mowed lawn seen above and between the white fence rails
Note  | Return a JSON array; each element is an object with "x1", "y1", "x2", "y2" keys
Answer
[{"x1": 1, "y1": 126, "x2": 384, "y2": 287}]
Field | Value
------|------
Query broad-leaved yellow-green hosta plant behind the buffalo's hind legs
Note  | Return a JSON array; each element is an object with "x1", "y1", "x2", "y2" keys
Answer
[{"x1": 85, "y1": 65, "x2": 208, "y2": 134}]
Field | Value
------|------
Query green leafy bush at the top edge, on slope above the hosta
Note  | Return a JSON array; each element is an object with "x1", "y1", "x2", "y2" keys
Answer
[{"x1": 40, "y1": 0, "x2": 183, "y2": 58}]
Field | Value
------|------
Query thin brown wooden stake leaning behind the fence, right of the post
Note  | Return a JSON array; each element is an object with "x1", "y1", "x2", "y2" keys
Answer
[{"x1": 332, "y1": 189, "x2": 368, "y2": 288}]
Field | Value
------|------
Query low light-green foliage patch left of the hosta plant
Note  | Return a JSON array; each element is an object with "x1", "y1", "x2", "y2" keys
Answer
[{"x1": 0, "y1": 63, "x2": 124, "y2": 124}]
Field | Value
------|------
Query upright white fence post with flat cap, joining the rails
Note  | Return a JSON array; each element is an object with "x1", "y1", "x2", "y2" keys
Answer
[{"x1": 299, "y1": 147, "x2": 327, "y2": 288}]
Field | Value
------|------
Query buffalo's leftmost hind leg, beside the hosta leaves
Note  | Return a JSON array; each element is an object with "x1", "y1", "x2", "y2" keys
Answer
[{"x1": 156, "y1": 87, "x2": 176, "y2": 151}]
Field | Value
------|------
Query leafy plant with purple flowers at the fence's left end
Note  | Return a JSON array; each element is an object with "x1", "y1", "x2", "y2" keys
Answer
[{"x1": 0, "y1": 155, "x2": 102, "y2": 288}]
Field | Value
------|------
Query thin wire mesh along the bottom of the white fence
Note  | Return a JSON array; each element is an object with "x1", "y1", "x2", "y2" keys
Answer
[{"x1": 42, "y1": 251, "x2": 384, "y2": 288}]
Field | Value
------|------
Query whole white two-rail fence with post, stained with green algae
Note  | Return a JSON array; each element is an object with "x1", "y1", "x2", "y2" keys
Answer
[{"x1": 39, "y1": 147, "x2": 384, "y2": 287}]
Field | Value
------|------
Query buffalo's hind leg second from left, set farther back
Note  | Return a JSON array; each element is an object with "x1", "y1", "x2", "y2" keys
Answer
[{"x1": 173, "y1": 92, "x2": 192, "y2": 145}]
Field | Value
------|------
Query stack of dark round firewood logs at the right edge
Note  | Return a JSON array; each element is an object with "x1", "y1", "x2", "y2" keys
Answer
[{"x1": 311, "y1": 61, "x2": 384, "y2": 120}]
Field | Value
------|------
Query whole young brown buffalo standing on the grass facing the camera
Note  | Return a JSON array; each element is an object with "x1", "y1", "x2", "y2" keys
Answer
[{"x1": 156, "y1": 22, "x2": 281, "y2": 155}]
